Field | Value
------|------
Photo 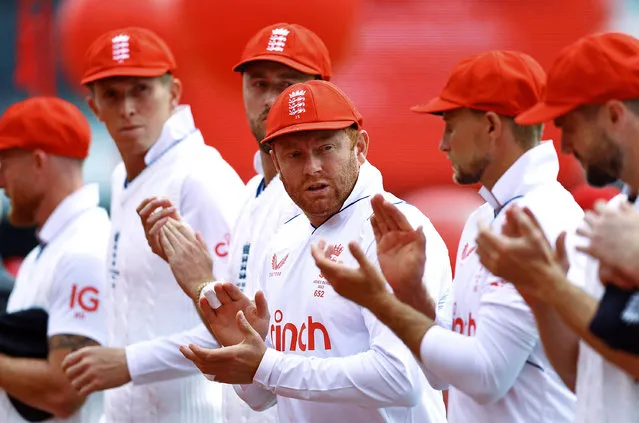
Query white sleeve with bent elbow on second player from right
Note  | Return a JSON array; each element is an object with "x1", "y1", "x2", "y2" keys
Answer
[{"x1": 421, "y1": 275, "x2": 540, "y2": 404}]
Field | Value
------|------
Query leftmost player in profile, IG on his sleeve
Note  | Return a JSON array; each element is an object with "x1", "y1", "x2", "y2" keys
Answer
[{"x1": 0, "y1": 97, "x2": 110, "y2": 423}]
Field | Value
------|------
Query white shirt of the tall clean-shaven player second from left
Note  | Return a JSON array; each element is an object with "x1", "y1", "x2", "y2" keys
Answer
[{"x1": 105, "y1": 106, "x2": 245, "y2": 423}]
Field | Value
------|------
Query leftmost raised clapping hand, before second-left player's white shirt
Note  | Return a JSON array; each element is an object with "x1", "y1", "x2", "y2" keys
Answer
[{"x1": 136, "y1": 197, "x2": 181, "y2": 262}]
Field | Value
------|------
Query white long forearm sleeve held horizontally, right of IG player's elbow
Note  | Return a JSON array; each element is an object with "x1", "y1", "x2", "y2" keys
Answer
[{"x1": 125, "y1": 324, "x2": 220, "y2": 385}]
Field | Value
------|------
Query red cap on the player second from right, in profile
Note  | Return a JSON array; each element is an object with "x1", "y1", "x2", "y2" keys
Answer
[{"x1": 411, "y1": 50, "x2": 546, "y2": 117}]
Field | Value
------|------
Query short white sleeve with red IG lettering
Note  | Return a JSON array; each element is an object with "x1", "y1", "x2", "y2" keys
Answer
[{"x1": 47, "y1": 252, "x2": 107, "y2": 344}]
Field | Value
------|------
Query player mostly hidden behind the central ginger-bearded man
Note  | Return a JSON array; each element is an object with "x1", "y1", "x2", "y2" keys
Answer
[{"x1": 129, "y1": 23, "x2": 331, "y2": 423}]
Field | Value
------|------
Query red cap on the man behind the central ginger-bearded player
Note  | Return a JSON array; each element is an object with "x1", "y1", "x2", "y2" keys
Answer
[{"x1": 233, "y1": 23, "x2": 332, "y2": 81}]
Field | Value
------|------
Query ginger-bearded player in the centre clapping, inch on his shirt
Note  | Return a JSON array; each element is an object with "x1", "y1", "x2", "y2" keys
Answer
[{"x1": 162, "y1": 81, "x2": 451, "y2": 422}]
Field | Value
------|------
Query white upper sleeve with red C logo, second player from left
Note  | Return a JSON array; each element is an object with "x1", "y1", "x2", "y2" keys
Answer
[{"x1": 180, "y1": 172, "x2": 246, "y2": 280}]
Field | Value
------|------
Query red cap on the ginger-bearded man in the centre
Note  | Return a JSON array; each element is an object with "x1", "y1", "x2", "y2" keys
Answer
[{"x1": 262, "y1": 80, "x2": 364, "y2": 143}]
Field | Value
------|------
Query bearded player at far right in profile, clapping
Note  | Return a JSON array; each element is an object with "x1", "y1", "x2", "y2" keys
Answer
[{"x1": 478, "y1": 33, "x2": 639, "y2": 423}]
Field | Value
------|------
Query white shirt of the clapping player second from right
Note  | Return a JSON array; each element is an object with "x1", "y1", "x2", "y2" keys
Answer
[{"x1": 421, "y1": 141, "x2": 583, "y2": 423}]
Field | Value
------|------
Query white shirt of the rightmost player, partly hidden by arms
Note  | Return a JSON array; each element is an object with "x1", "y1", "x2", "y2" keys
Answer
[{"x1": 571, "y1": 194, "x2": 639, "y2": 423}]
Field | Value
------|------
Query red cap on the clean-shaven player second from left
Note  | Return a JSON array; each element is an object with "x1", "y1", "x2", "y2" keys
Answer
[{"x1": 80, "y1": 27, "x2": 177, "y2": 84}]
